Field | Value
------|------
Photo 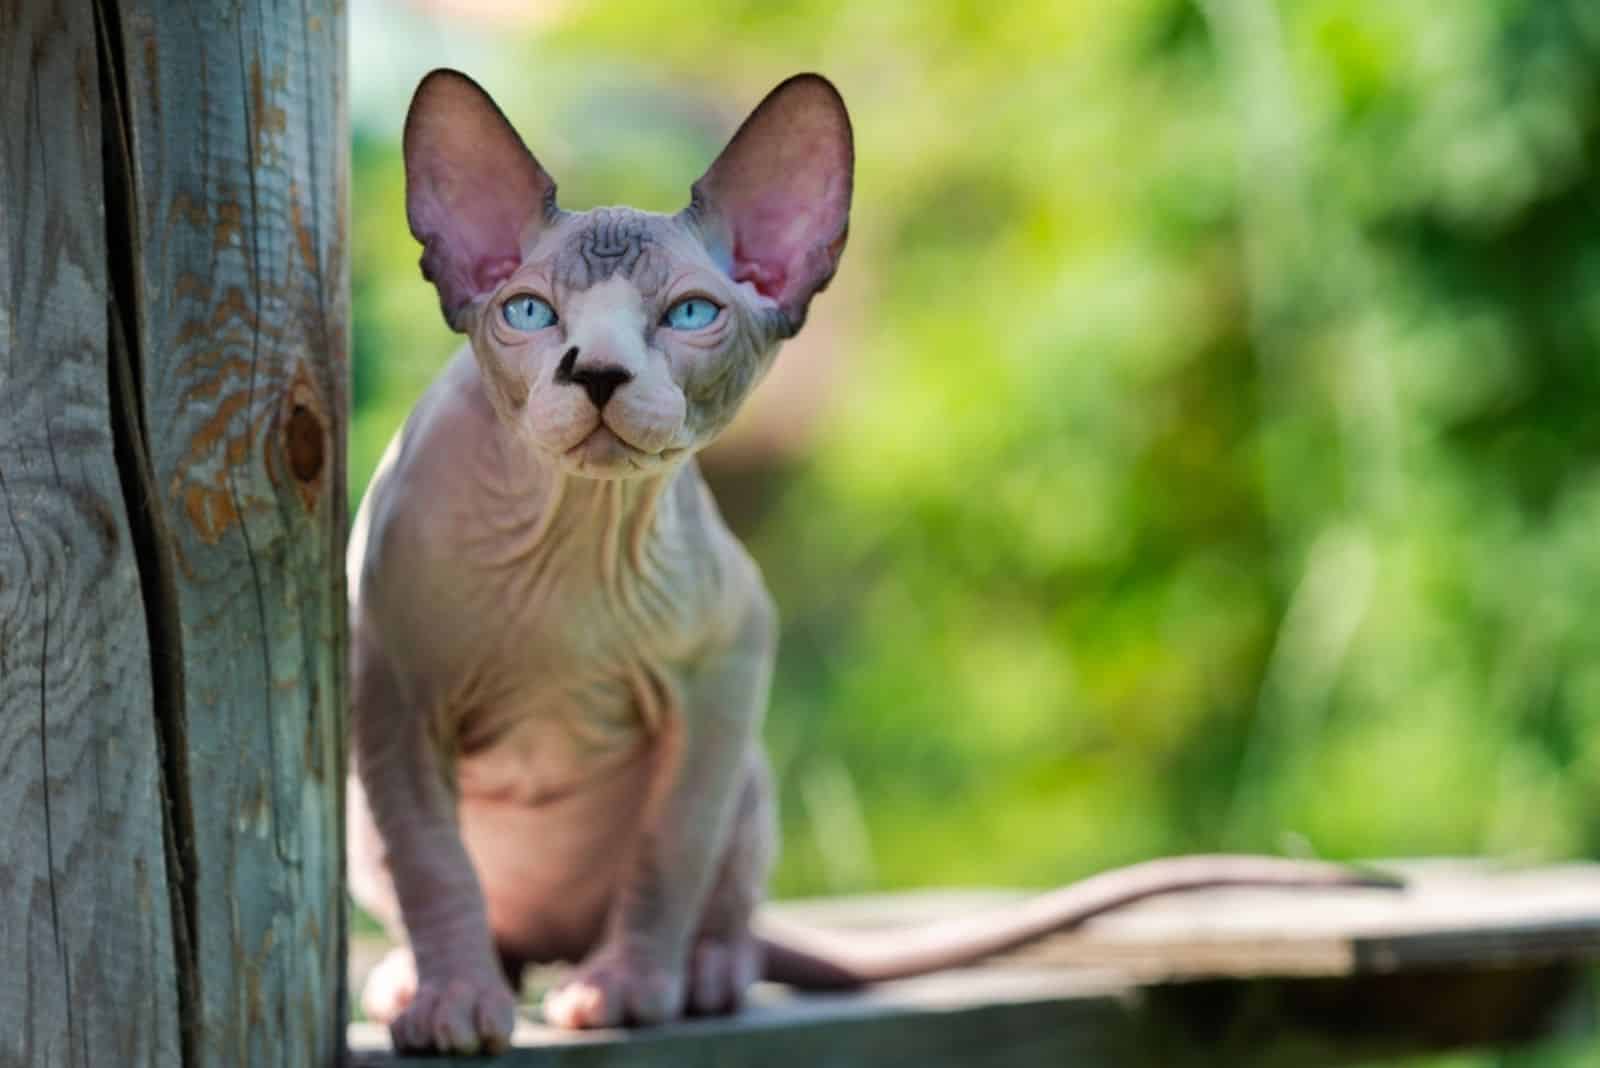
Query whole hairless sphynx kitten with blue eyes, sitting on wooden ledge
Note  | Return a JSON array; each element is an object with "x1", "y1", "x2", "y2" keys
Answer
[{"x1": 349, "y1": 70, "x2": 1401, "y2": 1054}]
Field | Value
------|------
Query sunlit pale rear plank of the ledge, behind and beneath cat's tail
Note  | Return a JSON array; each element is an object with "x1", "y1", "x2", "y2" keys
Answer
[{"x1": 773, "y1": 862, "x2": 1600, "y2": 983}]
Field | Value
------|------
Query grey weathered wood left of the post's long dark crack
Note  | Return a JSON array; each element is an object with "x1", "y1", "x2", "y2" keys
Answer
[{"x1": 0, "y1": 0, "x2": 179, "y2": 1068}]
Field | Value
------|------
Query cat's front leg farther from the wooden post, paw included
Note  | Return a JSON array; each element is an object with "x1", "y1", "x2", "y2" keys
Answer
[{"x1": 544, "y1": 593, "x2": 776, "y2": 1028}]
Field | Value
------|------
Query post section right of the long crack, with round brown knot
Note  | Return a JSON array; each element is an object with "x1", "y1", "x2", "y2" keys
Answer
[{"x1": 115, "y1": 0, "x2": 349, "y2": 1068}]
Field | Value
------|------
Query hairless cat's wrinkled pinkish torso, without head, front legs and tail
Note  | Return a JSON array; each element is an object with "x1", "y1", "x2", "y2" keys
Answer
[{"x1": 349, "y1": 340, "x2": 771, "y2": 1015}]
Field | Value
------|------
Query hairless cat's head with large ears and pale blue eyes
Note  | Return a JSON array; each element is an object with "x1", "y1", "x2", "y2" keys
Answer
[{"x1": 405, "y1": 70, "x2": 853, "y2": 478}]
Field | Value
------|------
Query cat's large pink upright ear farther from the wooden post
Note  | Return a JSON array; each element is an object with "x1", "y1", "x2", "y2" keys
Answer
[{"x1": 686, "y1": 74, "x2": 856, "y2": 333}]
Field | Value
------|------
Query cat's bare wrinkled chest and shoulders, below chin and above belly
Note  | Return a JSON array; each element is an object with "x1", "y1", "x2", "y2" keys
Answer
[{"x1": 357, "y1": 412, "x2": 754, "y2": 803}]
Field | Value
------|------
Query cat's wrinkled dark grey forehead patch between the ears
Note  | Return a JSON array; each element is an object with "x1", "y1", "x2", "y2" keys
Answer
[{"x1": 534, "y1": 208, "x2": 710, "y2": 299}]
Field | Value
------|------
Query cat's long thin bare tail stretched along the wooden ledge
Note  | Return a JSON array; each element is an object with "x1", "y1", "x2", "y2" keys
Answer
[{"x1": 762, "y1": 854, "x2": 1405, "y2": 990}]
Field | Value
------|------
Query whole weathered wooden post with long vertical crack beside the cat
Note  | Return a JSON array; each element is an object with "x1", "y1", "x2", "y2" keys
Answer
[{"x1": 0, "y1": 0, "x2": 349, "y2": 1068}]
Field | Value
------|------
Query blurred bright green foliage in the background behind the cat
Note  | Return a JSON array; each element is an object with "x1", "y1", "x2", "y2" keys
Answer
[{"x1": 350, "y1": 0, "x2": 1600, "y2": 1063}]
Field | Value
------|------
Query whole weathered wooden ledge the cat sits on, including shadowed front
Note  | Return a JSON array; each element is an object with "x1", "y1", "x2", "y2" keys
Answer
[{"x1": 352, "y1": 865, "x2": 1600, "y2": 1068}]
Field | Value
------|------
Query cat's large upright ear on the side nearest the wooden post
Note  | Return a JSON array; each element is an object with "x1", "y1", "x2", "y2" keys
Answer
[{"x1": 405, "y1": 69, "x2": 557, "y2": 329}]
